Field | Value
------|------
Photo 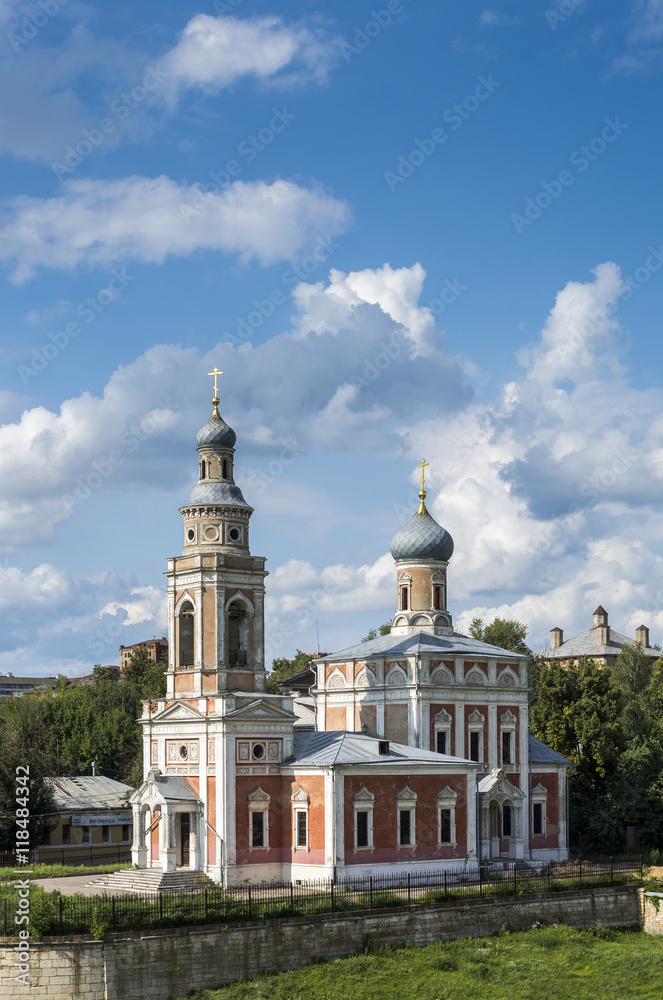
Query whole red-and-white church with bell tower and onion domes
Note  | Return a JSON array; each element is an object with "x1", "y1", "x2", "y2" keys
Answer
[{"x1": 130, "y1": 379, "x2": 571, "y2": 885}]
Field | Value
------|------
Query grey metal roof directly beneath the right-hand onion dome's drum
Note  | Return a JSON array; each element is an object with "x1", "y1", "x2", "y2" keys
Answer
[{"x1": 316, "y1": 631, "x2": 523, "y2": 663}]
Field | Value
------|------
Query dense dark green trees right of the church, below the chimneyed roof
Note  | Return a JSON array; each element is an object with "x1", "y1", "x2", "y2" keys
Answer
[{"x1": 531, "y1": 646, "x2": 663, "y2": 852}]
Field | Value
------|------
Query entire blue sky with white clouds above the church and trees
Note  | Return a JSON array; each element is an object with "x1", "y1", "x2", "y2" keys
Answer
[{"x1": 0, "y1": 0, "x2": 663, "y2": 674}]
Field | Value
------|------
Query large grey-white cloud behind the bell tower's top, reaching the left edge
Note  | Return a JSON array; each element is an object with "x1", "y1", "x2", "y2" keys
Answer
[{"x1": 0, "y1": 265, "x2": 471, "y2": 551}]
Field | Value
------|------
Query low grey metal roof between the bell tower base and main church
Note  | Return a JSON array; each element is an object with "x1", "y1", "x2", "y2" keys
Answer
[{"x1": 284, "y1": 729, "x2": 476, "y2": 767}]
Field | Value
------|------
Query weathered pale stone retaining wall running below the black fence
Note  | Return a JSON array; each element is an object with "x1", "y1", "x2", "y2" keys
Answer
[{"x1": 0, "y1": 887, "x2": 644, "y2": 1000}]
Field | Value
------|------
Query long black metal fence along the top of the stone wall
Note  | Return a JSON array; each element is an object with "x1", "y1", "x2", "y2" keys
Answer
[{"x1": 0, "y1": 858, "x2": 642, "y2": 937}]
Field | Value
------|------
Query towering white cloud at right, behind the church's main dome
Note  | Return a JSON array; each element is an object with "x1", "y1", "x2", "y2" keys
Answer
[{"x1": 268, "y1": 263, "x2": 663, "y2": 648}]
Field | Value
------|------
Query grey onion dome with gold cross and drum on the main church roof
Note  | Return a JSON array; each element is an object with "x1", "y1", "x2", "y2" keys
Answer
[{"x1": 391, "y1": 458, "x2": 454, "y2": 635}]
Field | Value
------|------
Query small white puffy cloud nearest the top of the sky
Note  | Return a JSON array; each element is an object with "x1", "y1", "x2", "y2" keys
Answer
[{"x1": 163, "y1": 14, "x2": 338, "y2": 95}]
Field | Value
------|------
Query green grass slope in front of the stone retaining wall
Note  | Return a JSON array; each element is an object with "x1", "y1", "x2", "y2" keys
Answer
[{"x1": 173, "y1": 925, "x2": 663, "y2": 1000}]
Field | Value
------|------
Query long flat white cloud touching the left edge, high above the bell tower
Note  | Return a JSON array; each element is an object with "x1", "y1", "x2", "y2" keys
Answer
[{"x1": 0, "y1": 176, "x2": 349, "y2": 283}]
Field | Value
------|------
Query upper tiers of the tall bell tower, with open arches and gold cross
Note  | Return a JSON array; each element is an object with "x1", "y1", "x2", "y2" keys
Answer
[{"x1": 166, "y1": 367, "x2": 267, "y2": 699}]
